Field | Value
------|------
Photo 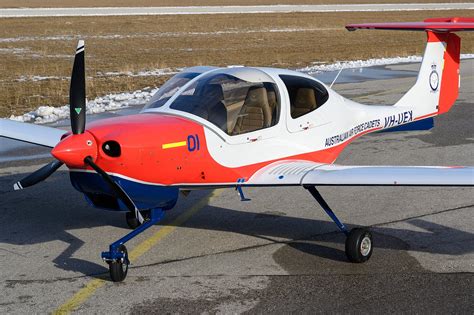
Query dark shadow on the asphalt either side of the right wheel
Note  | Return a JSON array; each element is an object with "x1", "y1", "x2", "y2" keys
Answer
[{"x1": 172, "y1": 206, "x2": 474, "y2": 261}]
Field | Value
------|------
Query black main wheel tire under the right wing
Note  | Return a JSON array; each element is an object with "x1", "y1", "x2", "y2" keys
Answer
[{"x1": 346, "y1": 228, "x2": 374, "y2": 263}]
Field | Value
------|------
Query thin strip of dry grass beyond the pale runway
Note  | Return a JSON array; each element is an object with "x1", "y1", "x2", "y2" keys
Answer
[{"x1": 0, "y1": 0, "x2": 469, "y2": 8}]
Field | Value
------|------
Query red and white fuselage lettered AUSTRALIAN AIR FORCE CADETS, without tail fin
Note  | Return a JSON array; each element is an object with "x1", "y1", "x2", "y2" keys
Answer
[{"x1": 53, "y1": 68, "x2": 434, "y2": 209}]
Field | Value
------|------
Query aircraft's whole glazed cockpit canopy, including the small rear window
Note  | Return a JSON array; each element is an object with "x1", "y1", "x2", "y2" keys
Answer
[{"x1": 144, "y1": 67, "x2": 328, "y2": 136}]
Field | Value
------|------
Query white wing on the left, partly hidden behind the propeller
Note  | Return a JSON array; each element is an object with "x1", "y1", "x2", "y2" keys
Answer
[{"x1": 0, "y1": 119, "x2": 66, "y2": 148}]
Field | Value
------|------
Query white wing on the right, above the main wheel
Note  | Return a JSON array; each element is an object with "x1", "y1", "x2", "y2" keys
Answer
[{"x1": 245, "y1": 161, "x2": 474, "y2": 186}]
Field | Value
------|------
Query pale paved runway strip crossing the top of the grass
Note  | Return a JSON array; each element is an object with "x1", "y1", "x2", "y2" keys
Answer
[{"x1": 0, "y1": 2, "x2": 474, "y2": 17}]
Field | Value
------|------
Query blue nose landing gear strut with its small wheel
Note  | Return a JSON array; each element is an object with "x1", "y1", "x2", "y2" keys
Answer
[{"x1": 101, "y1": 209, "x2": 165, "y2": 282}]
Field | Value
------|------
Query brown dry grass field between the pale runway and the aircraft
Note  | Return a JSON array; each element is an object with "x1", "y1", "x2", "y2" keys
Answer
[{"x1": 0, "y1": 11, "x2": 474, "y2": 117}]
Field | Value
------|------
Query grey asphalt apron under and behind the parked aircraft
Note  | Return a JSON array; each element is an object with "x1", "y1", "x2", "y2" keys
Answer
[{"x1": 0, "y1": 60, "x2": 474, "y2": 314}]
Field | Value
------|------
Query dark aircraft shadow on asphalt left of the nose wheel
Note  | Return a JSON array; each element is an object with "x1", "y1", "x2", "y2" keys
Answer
[{"x1": 0, "y1": 171, "x2": 126, "y2": 275}]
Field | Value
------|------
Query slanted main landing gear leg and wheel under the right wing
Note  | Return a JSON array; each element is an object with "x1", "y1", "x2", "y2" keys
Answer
[{"x1": 305, "y1": 186, "x2": 373, "y2": 263}]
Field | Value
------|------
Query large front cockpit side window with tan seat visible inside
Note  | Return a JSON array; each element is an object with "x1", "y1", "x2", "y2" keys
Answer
[{"x1": 170, "y1": 70, "x2": 280, "y2": 135}]
